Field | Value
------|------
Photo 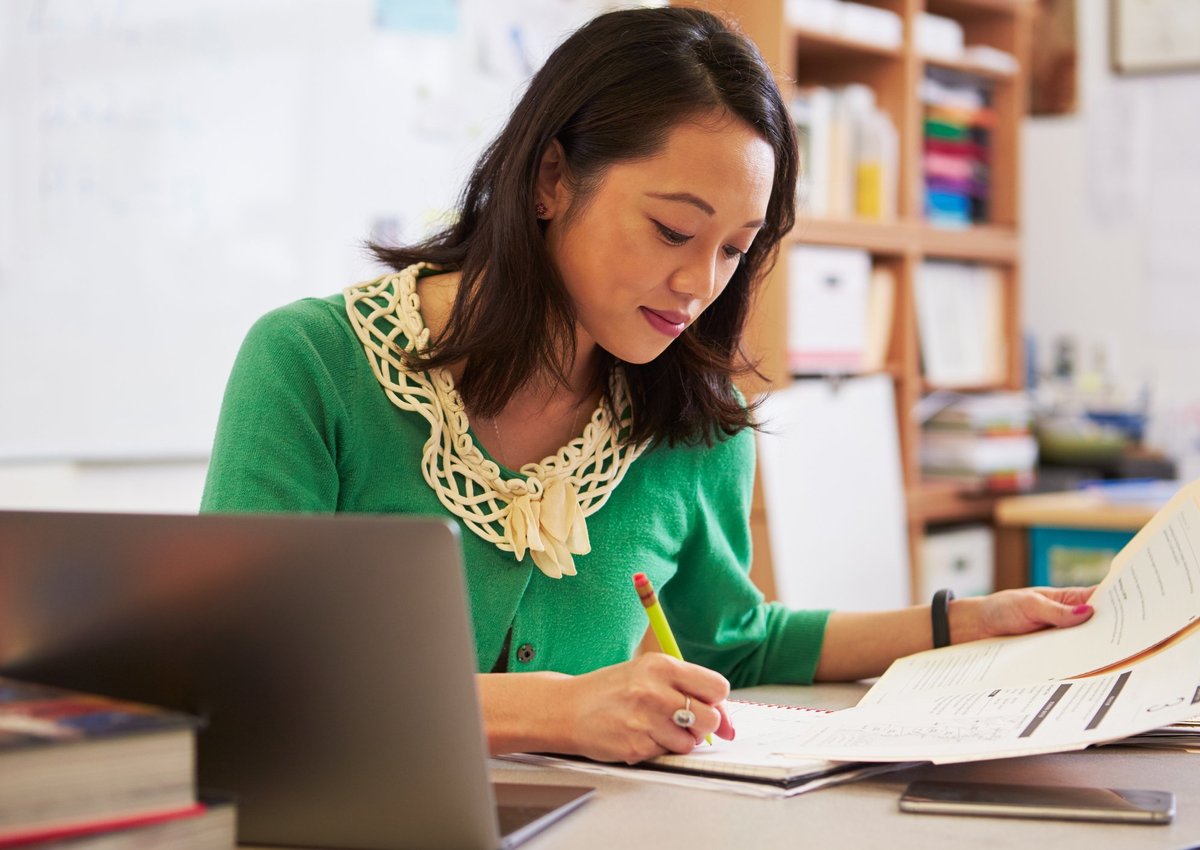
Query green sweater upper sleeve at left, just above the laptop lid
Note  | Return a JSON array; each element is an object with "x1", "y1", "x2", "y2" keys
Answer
[{"x1": 200, "y1": 299, "x2": 359, "y2": 513}]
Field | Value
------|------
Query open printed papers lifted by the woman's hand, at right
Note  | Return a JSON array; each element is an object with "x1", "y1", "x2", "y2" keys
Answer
[{"x1": 777, "y1": 481, "x2": 1200, "y2": 764}]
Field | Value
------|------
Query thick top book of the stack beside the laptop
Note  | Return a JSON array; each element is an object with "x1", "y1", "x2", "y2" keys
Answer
[{"x1": 0, "y1": 678, "x2": 196, "y2": 842}]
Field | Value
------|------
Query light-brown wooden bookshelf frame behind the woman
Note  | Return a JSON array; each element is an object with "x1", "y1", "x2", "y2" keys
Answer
[{"x1": 680, "y1": 0, "x2": 1034, "y2": 601}]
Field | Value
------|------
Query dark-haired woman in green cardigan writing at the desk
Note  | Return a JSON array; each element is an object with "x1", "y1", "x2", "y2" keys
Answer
[{"x1": 204, "y1": 8, "x2": 1091, "y2": 761}]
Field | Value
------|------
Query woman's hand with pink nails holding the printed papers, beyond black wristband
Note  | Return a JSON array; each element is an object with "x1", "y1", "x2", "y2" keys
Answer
[{"x1": 949, "y1": 587, "x2": 1094, "y2": 644}]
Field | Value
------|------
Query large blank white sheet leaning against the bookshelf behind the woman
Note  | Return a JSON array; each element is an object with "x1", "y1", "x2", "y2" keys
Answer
[{"x1": 757, "y1": 375, "x2": 911, "y2": 610}]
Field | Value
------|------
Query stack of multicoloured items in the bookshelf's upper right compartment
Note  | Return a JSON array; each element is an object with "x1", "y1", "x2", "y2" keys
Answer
[{"x1": 920, "y1": 71, "x2": 996, "y2": 227}]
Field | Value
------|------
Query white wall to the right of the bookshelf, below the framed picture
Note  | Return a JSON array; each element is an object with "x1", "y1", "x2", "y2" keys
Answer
[{"x1": 1021, "y1": 0, "x2": 1200, "y2": 477}]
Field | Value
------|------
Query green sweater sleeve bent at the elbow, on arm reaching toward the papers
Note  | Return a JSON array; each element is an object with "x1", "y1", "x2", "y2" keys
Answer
[{"x1": 659, "y1": 431, "x2": 829, "y2": 688}]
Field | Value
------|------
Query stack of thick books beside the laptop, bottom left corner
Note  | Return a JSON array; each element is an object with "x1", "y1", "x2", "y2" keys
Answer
[{"x1": 0, "y1": 678, "x2": 236, "y2": 850}]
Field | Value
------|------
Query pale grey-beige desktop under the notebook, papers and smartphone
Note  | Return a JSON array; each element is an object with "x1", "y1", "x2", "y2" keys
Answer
[{"x1": 492, "y1": 686, "x2": 1200, "y2": 850}]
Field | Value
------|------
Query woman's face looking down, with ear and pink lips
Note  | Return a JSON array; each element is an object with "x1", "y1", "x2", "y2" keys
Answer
[{"x1": 539, "y1": 115, "x2": 775, "y2": 363}]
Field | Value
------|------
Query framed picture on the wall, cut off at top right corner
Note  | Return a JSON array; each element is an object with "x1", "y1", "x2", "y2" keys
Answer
[{"x1": 1109, "y1": 0, "x2": 1200, "y2": 73}]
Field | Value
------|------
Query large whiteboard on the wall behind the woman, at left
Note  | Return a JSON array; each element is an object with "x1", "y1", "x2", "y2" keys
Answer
[{"x1": 0, "y1": 0, "x2": 619, "y2": 460}]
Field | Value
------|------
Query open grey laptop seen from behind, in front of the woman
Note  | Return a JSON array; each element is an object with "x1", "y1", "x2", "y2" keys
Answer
[{"x1": 0, "y1": 511, "x2": 593, "y2": 850}]
